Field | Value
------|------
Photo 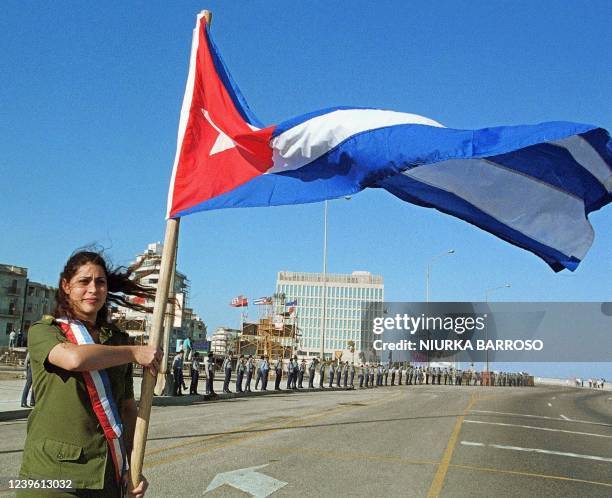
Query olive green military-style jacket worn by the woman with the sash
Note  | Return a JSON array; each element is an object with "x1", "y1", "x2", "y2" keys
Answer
[{"x1": 19, "y1": 317, "x2": 134, "y2": 489}]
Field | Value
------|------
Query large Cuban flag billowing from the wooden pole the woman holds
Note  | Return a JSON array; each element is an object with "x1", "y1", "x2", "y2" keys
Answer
[{"x1": 167, "y1": 14, "x2": 612, "y2": 271}]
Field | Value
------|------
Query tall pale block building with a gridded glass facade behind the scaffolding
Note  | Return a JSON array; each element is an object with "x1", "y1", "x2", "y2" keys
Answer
[{"x1": 276, "y1": 271, "x2": 384, "y2": 362}]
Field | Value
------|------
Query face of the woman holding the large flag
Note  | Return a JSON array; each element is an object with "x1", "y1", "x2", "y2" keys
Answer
[{"x1": 62, "y1": 263, "x2": 108, "y2": 323}]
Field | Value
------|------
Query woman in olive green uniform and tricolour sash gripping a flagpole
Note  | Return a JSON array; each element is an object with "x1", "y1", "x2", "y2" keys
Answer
[{"x1": 19, "y1": 251, "x2": 162, "y2": 498}]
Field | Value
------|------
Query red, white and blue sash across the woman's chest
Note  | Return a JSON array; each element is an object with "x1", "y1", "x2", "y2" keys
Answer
[{"x1": 56, "y1": 318, "x2": 129, "y2": 482}]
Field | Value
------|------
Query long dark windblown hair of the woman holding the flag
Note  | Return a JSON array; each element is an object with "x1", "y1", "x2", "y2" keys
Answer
[{"x1": 53, "y1": 250, "x2": 155, "y2": 326}]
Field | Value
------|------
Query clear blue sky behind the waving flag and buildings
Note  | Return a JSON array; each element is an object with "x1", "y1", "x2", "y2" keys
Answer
[{"x1": 0, "y1": 0, "x2": 612, "y2": 376}]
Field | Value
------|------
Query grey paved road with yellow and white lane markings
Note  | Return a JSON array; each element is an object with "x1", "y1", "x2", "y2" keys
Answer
[{"x1": 0, "y1": 386, "x2": 612, "y2": 497}]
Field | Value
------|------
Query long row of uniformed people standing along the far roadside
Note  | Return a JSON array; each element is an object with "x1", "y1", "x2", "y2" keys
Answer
[{"x1": 172, "y1": 351, "x2": 532, "y2": 396}]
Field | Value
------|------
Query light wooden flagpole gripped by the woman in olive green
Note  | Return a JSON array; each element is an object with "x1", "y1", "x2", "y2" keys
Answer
[{"x1": 130, "y1": 11, "x2": 212, "y2": 487}]
